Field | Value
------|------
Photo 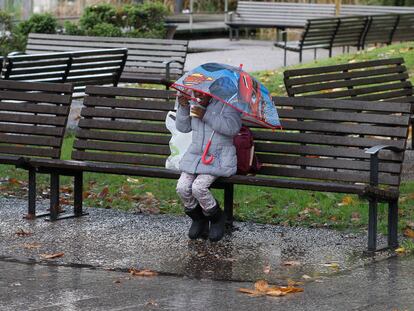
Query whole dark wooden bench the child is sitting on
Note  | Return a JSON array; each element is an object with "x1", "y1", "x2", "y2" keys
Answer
[{"x1": 25, "y1": 86, "x2": 411, "y2": 251}]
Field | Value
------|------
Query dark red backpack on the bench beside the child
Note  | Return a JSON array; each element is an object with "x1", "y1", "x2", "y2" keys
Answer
[{"x1": 233, "y1": 126, "x2": 262, "y2": 175}]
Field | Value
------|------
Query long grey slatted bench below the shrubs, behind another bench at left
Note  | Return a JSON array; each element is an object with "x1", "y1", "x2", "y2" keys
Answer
[{"x1": 26, "y1": 33, "x2": 188, "y2": 87}]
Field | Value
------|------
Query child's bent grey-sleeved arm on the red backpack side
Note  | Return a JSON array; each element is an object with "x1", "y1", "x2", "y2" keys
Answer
[{"x1": 203, "y1": 103, "x2": 242, "y2": 136}]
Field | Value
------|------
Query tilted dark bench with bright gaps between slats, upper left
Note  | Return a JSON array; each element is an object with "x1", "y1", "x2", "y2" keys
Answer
[{"x1": 2, "y1": 49, "x2": 128, "y2": 97}]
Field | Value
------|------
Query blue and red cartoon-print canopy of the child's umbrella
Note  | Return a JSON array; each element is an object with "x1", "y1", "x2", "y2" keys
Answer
[{"x1": 172, "y1": 63, "x2": 281, "y2": 129}]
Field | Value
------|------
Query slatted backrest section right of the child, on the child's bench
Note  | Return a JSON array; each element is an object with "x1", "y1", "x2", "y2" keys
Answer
[{"x1": 254, "y1": 97, "x2": 410, "y2": 190}]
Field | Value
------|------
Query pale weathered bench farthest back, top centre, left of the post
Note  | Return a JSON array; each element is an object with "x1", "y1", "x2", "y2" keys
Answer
[{"x1": 226, "y1": 1, "x2": 335, "y2": 39}]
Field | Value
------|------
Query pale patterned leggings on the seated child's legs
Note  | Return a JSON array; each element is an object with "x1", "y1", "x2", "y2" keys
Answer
[{"x1": 176, "y1": 172, "x2": 217, "y2": 211}]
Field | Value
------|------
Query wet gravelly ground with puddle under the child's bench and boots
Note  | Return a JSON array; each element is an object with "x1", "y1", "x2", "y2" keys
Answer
[{"x1": 0, "y1": 199, "x2": 390, "y2": 282}]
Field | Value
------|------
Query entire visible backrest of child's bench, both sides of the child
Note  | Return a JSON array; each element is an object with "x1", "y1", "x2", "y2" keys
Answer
[{"x1": 72, "y1": 87, "x2": 410, "y2": 191}]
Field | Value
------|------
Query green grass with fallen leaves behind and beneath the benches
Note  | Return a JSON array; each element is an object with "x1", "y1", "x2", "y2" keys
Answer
[{"x1": 0, "y1": 43, "x2": 414, "y2": 236}]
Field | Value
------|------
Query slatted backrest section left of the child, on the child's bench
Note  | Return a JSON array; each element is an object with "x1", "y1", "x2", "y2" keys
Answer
[{"x1": 72, "y1": 86, "x2": 175, "y2": 167}]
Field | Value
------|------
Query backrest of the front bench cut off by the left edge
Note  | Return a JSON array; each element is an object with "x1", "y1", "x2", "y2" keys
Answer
[{"x1": 0, "y1": 80, "x2": 73, "y2": 159}]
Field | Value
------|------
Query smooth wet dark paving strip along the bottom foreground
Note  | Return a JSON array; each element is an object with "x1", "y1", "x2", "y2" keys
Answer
[{"x1": 0, "y1": 257, "x2": 414, "y2": 311}]
